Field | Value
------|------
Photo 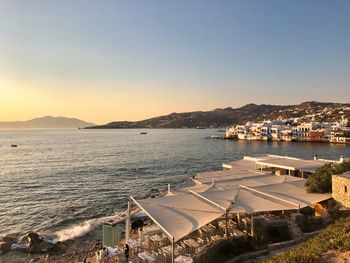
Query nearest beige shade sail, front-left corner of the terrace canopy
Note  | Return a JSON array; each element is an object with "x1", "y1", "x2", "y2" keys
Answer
[{"x1": 137, "y1": 194, "x2": 224, "y2": 242}]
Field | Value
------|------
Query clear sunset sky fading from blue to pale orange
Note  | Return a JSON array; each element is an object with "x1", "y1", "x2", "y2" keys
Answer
[{"x1": 0, "y1": 0, "x2": 350, "y2": 124}]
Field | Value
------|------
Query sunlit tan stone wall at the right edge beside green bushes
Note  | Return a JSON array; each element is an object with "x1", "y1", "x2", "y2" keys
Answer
[{"x1": 332, "y1": 175, "x2": 350, "y2": 208}]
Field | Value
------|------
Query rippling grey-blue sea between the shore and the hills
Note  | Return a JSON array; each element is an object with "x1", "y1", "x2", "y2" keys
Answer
[{"x1": 0, "y1": 129, "x2": 350, "y2": 241}]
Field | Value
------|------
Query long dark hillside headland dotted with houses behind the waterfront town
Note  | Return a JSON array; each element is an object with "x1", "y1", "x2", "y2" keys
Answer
[{"x1": 86, "y1": 101, "x2": 350, "y2": 129}]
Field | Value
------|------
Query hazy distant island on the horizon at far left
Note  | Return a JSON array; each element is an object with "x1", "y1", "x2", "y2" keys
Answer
[{"x1": 0, "y1": 116, "x2": 95, "y2": 129}]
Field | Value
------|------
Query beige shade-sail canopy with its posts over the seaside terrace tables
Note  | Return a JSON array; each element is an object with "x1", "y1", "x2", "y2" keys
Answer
[{"x1": 126, "y1": 175, "x2": 331, "y2": 262}]
